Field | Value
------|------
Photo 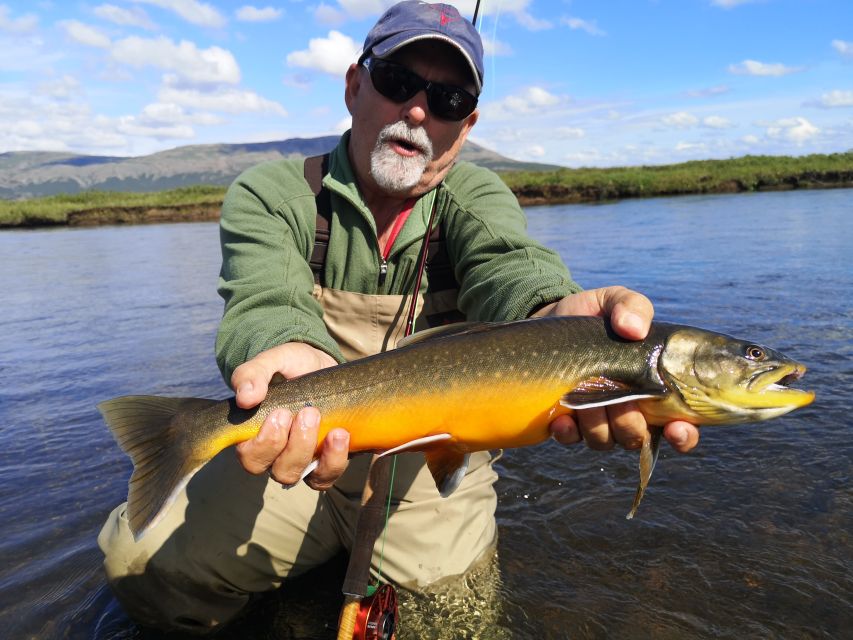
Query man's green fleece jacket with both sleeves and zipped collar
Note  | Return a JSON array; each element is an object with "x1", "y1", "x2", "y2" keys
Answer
[{"x1": 216, "y1": 134, "x2": 580, "y2": 381}]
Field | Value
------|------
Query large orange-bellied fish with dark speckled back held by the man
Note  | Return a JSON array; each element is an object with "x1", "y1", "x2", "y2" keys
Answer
[{"x1": 98, "y1": 317, "x2": 814, "y2": 535}]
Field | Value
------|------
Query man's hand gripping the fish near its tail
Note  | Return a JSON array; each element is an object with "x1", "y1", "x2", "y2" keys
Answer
[{"x1": 231, "y1": 342, "x2": 349, "y2": 490}]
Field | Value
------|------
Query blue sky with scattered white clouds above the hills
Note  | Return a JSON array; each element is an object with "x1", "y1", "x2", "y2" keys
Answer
[{"x1": 0, "y1": 0, "x2": 853, "y2": 167}]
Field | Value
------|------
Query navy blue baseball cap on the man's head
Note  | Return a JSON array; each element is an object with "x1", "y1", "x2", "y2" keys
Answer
[{"x1": 358, "y1": 0, "x2": 483, "y2": 94}]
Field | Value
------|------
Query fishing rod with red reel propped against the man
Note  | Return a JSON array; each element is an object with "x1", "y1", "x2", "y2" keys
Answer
[{"x1": 337, "y1": 0, "x2": 480, "y2": 640}]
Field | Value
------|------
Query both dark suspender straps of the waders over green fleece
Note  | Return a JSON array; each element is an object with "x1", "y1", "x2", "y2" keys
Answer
[{"x1": 304, "y1": 153, "x2": 459, "y2": 294}]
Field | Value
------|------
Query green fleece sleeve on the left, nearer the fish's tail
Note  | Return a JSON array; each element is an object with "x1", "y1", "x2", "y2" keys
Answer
[{"x1": 216, "y1": 166, "x2": 344, "y2": 382}]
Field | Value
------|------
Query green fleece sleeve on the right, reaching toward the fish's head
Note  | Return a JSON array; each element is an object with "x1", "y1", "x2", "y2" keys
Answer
[{"x1": 446, "y1": 166, "x2": 581, "y2": 321}]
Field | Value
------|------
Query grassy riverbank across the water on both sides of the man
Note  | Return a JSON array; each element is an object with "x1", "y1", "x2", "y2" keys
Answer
[{"x1": 0, "y1": 151, "x2": 853, "y2": 228}]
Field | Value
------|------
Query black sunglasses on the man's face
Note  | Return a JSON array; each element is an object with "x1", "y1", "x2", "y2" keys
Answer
[{"x1": 362, "y1": 58, "x2": 477, "y2": 120}]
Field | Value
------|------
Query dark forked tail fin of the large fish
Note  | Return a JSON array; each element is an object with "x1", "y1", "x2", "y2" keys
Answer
[{"x1": 98, "y1": 396, "x2": 217, "y2": 539}]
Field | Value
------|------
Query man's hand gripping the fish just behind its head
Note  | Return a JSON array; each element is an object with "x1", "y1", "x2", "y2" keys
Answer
[{"x1": 534, "y1": 287, "x2": 699, "y2": 453}]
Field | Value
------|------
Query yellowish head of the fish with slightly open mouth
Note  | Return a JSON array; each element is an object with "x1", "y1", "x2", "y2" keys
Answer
[{"x1": 658, "y1": 328, "x2": 814, "y2": 424}]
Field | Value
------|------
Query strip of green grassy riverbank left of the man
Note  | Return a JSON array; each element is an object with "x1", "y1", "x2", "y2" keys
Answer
[{"x1": 0, "y1": 186, "x2": 226, "y2": 227}]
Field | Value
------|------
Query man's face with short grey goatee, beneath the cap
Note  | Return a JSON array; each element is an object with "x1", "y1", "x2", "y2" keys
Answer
[{"x1": 346, "y1": 41, "x2": 478, "y2": 198}]
